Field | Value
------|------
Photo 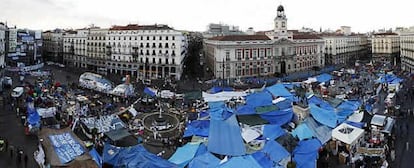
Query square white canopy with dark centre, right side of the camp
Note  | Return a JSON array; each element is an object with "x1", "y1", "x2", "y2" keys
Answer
[{"x1": 332, "y1": 123, "x2": 364, "y2": 145}]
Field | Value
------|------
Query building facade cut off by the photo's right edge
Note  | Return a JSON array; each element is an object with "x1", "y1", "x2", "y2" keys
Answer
[{"x1": 400, "y1": 31, "x2": 414, "y2": 73}]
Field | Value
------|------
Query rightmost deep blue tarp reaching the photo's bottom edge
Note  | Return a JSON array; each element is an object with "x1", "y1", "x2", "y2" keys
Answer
[{"x1": 293, "y1": 139, "x2": 322, "y2": 168}]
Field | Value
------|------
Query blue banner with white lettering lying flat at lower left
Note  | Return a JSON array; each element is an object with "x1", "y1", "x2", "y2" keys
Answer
[{"x1": 49, "y1": 133, "x2": 85, "y2": 164}]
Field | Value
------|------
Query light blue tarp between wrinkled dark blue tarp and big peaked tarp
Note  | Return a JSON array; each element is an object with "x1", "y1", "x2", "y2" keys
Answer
[{"x1": 168, "y1": 143, "x2": 200, "y2": 168}]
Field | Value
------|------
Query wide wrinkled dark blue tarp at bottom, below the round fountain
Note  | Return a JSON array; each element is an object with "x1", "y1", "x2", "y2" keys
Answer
[{"x1": 103, "y1": 143, "x2": 178, "y2": 168}]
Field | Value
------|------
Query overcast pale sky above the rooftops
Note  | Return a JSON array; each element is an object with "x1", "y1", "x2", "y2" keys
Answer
[{"x1": 0, "y1": 0, "x2": 414, "y2": 33}]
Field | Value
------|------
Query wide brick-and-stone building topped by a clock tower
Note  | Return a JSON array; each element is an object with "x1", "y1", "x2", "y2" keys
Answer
[{"x1": 204, "y1": 6, "x2": 325, "y2": 79}]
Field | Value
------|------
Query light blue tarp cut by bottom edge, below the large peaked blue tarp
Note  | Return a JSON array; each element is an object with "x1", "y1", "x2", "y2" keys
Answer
[{"x1": 219, "y1": 155, "x2": 262, "y2": 168}]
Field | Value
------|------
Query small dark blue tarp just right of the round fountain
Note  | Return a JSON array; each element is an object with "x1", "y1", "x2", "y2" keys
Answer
[{"x1": 183, "y1": 120, "x2": 210, "y2": 137}]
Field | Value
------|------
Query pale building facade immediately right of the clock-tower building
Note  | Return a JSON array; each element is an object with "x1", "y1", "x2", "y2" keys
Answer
[{"x1": 321, "y1": 34, "x2": 369, "y2": 65}]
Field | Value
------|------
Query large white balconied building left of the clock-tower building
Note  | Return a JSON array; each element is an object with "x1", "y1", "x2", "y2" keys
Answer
[{"x1": 63, "y1": 24, "x2": 188, "y2": 79}]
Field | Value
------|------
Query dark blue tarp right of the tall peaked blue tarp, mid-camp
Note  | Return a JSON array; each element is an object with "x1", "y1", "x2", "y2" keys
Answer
[{"x1": 260, "y1": 108, "x2": 293, "y2": 126}]
